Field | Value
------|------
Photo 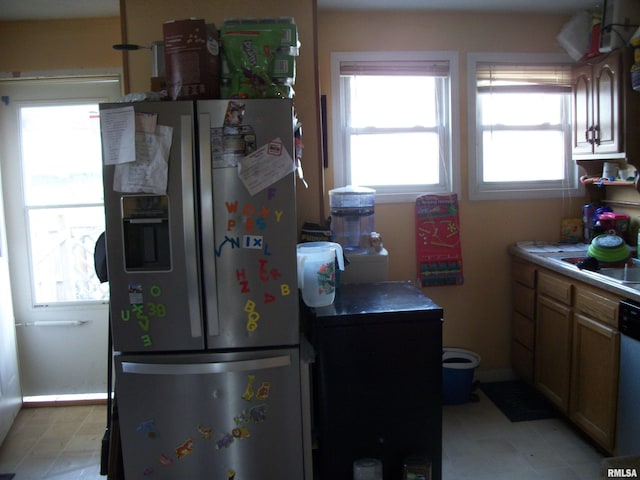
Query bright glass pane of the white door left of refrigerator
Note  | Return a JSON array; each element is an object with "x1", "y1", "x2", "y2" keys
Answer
[{"x1": 20, "y1": 103, "x2": 108, "y2": 305}]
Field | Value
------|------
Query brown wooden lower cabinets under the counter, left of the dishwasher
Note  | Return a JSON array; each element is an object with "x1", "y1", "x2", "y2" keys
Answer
[{"x1": 511, "y1": 260, "x2": 622, "y2": 454}]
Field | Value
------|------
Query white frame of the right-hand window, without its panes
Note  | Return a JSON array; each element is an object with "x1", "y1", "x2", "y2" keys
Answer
[{"x1": 467, "y1": 52, "x2": 584, "y2": 201}]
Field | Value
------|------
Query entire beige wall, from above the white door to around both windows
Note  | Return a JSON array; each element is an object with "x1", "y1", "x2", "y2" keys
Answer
[{"x1": 0, "y1": 6, "x2": 604, "y2": 376}]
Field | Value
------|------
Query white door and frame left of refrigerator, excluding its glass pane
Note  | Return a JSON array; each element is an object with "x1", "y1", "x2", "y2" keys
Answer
[{"x1": 0, "y1": 74, "x2": 121, "y2": 398}]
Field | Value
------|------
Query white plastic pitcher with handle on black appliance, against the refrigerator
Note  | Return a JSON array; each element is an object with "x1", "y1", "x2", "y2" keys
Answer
[{"x1": 297, "y1": 242, "x2": 344, "y2": 307}]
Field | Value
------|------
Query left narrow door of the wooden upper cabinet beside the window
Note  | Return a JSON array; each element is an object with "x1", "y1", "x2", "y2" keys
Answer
[{"x1": 572, "y1": 66, "x2": 593, "y2": 155}]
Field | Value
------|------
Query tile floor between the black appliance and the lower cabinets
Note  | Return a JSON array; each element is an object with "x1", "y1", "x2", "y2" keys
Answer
[{"x1": 442, "y1": 391, "x2": 603, "y2": 480}]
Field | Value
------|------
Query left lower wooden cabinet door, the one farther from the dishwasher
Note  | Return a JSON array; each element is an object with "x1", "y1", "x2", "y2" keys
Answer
[{"x1": 534, "y1": 295, "x2": 573, "y2": 412}]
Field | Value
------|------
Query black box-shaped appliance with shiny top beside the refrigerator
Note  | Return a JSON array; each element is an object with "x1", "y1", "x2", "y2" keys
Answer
[{"x1": 304, "y1": 282, "x2": 443, "y2": 480}]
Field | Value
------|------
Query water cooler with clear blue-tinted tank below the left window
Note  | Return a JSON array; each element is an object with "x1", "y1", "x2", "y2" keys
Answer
[{"x1": 329, "y1": 185, "x2": 389, "y2": 283}]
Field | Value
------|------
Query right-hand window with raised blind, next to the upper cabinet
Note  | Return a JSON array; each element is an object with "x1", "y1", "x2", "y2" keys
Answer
[{"x1": 468, "y1": 53, "x2": 579, "y2": 200}]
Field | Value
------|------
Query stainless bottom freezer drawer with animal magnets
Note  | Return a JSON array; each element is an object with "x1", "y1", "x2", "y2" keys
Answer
[{"x1": 116, "y1": 348, "x2": 304, "y2": 480}]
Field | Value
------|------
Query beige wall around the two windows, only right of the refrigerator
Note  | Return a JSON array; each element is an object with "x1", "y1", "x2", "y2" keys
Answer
[{"x1": 318, "y1": 11, "x2": 585, "y2": 370}]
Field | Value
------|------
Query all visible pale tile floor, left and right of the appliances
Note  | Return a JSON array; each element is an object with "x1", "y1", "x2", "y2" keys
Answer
[{"x1": 0, "y1": 392, "x2": 602, "y2": 480}]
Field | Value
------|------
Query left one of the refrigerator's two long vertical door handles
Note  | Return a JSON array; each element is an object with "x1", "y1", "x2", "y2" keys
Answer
[{"x1": 180, "y1": 115, "x2": 202, "y2": 338}]
